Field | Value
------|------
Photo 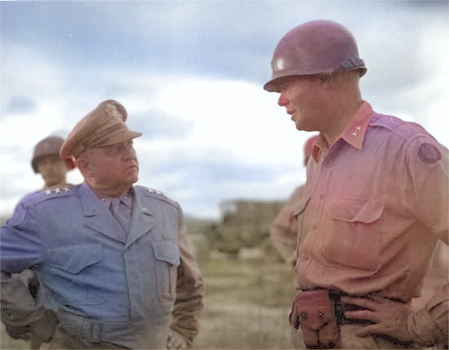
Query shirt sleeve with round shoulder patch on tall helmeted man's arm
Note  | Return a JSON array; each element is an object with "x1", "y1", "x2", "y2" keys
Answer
[{"x1": 404, "y1": 136, "x2": 449, "y2": 348}]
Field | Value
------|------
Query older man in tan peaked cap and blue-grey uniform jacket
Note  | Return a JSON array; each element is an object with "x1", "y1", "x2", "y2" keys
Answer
[{"x1": 1, "y1": 100, "x2": 204, "y2": 349}]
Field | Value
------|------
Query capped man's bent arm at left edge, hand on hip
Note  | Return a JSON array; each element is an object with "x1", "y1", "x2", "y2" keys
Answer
[{"x1": 0, "y1": 201, "x2": 57, "y2": 341}]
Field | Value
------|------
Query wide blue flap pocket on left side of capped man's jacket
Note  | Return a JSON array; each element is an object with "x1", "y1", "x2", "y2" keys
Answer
[{"x1": 45, "y1": 244, "x2": 106, "y2": 305}]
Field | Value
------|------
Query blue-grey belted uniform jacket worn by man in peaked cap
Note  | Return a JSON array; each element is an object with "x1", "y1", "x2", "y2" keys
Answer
[{"x1": 1, "y1": 183, "x2": 203, "y2": 349}]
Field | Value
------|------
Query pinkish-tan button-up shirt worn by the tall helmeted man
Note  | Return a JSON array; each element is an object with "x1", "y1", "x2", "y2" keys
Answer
[{"x1": 295, "y1": 102, "x2": 449, "y2": 302}]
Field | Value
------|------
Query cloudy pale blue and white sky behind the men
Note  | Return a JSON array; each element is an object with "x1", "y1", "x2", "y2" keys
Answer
[{"x1": 0, "y1": 0, "x2": 449, "y2": 219}]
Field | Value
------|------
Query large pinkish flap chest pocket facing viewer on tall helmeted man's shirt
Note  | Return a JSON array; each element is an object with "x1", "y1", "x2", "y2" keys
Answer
[{"x1": 322, "y1": 198, "x2": 384, "y2": 273}]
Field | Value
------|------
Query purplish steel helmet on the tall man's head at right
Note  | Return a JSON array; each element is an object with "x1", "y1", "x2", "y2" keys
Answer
[{"x1": 264, "y1": 20, "x2": 366, "y2": 92}]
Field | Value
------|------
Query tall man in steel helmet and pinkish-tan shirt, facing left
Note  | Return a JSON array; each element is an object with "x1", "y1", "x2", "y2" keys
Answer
[{"x1": 264, "y1": 21, "x2": 449, "y2": 348}]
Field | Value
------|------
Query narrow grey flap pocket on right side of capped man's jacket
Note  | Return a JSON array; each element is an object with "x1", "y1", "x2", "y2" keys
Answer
[{"x1": 152, "y1": 241, "x2": 180, "y2": 302}]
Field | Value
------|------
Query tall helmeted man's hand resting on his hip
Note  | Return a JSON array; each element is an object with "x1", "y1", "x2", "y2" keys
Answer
[{"x1": 341, "y1": 296, "x2": 413, "y2": 342}]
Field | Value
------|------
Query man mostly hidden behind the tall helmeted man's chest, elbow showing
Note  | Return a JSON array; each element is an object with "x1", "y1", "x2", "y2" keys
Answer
[{"x1": 270, "y1": 135, "x2": 318, "y2": 265}]
